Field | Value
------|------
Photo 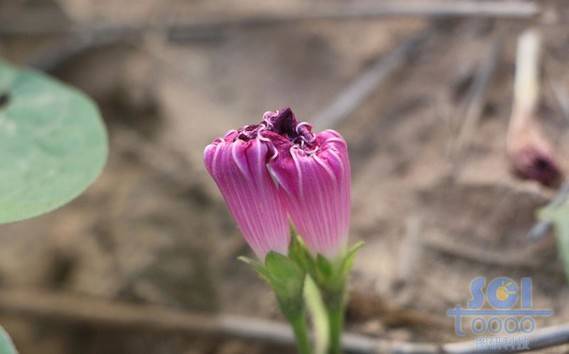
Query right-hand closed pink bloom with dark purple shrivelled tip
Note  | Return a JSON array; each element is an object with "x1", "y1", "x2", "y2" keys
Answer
[{"x1": 265, "y1": 108, "x2": 351, "y2": 257}]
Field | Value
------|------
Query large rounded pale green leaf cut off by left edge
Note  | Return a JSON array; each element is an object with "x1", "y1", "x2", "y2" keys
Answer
[{"x1": 0, "y1": 60, "x2": 108, "y2": 223}]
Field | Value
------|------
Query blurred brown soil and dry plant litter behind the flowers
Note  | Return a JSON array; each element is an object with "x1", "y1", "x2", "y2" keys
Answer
[{"x1": 0, "y1": 0, "x2": 569, "y2": 354}]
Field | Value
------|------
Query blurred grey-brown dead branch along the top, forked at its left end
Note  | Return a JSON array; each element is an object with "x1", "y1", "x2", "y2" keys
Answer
[{"x1": 22, "y1": 0, "x2": 540, "y2": 71}]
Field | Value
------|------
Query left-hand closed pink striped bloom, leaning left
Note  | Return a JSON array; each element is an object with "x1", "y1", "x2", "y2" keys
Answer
[{"x1": 204, "y1": 125, "x2": 290, "y2": 260}]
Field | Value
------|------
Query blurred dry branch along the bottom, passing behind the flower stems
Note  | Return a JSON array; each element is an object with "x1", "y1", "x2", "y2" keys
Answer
[{"x1": 0, "y1": 290, "x2": 569, "y2": 354}]
